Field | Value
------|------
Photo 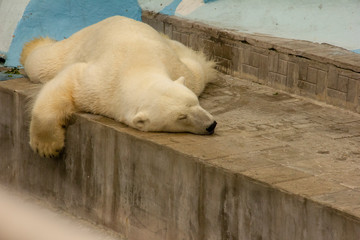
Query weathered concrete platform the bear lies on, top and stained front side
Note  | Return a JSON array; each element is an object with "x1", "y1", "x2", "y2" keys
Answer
[{"x1": 0, "y1": 75, "x2": 360, "y2": 240}]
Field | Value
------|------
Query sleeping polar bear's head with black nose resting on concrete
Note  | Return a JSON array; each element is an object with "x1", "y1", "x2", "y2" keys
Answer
[{"x1": 130, "y1": 78, "x2": 216, "y2": 134}]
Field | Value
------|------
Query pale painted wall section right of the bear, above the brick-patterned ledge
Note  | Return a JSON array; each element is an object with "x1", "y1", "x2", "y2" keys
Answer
[{"x1": 139, "y1": 0, "x2": 360, "y2": 51}]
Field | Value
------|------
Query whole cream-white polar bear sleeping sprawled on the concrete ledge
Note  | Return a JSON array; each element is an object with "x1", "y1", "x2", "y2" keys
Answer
[{"x1": 20, "y1": 16, "x2": 216, "y2": 157}]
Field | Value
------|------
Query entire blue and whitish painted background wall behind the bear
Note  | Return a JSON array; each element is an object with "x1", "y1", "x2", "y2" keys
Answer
[{"x1": 0, "y1": 0, "x2": 360, "y2": 66}]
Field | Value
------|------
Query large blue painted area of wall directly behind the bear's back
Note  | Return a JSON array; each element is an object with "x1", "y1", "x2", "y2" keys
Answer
[{"x1": 5, "y1": 0, "x2": 141, "y2": 66}]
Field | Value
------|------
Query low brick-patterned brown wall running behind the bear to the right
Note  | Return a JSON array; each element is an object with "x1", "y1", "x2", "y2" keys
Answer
[{"x1": 142, "y1": 11, "x2": 360, "y2": 112}]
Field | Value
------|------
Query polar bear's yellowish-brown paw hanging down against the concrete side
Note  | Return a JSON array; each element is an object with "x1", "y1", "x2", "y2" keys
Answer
[{"x1": 30, "y1": 123, "x2": 65, "y2": 158}]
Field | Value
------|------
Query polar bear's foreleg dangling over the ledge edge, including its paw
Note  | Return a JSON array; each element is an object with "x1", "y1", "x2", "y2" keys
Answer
[{"x1": 30, "y1": 63, "x2": 86, "y2": 157}]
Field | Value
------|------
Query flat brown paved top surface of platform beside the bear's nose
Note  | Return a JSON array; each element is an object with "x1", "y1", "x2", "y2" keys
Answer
[{"x1": 201, "y1": 76, "x2": 360, "y2": 202}]
